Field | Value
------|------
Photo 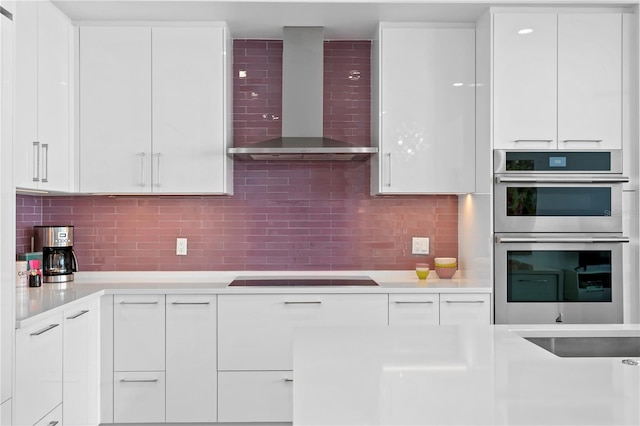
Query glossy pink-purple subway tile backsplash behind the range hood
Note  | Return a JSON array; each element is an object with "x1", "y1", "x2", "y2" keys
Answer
[{"x1": 16, "y1": 40, "x2": 458, "y2": 271}]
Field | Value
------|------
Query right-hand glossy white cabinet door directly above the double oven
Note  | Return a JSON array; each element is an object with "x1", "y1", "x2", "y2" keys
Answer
[{"x1": 558, "y1": 13, "x2": 622, "y2": 149}]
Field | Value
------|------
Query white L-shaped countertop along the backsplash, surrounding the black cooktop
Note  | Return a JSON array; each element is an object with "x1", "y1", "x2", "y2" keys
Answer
[{"x1": 16, "y1": 271, "x2": 491, "y2": 328}]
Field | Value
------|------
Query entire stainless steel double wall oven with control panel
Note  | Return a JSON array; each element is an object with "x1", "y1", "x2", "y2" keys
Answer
[{"x1": 494, "y1": 150, "x2": 629, "y2": 324}]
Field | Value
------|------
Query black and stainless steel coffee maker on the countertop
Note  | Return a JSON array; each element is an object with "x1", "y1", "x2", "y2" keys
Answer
[{"x1": 34, "y1": 226, "x2": 78, "y2": 283}]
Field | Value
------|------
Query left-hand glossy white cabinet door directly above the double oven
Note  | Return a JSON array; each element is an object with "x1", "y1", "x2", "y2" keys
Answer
[{"x1": 493, "y1": 13, "x2": 558, "y2": 149}]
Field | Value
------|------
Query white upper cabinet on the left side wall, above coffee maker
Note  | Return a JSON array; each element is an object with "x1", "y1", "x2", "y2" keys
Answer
[{"x1": 14, "y1": 1, "x2": 73, "y2": 192}]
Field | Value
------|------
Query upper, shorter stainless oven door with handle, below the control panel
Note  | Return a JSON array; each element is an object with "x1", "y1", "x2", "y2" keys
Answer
[{"x1": 494, "y1": 174, "x2": 628, "y2": 232}]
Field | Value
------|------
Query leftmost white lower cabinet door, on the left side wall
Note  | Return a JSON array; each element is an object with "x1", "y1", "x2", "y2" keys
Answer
[{"x1": 13, "y1": 314, "x2": 63, "y2": 426}]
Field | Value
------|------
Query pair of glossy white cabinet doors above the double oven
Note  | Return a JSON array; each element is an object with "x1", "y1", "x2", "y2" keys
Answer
[{"x1": 493, "y1": 13, "x2": 622, "y2": 149}]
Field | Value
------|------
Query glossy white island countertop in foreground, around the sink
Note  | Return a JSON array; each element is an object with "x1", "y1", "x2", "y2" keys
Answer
[{"x1": 293, "y1": 324, "x2": 640, "y2": 425}]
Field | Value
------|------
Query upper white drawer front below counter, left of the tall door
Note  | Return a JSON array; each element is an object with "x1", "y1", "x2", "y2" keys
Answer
[{"x1": 113, "y1": 295, "x2": 165, "y2": 371}]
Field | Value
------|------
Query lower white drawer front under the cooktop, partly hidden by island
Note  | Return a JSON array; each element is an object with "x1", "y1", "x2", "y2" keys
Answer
[{"x1": 218, "y1": 371, "x2": 293, "y2": 422}]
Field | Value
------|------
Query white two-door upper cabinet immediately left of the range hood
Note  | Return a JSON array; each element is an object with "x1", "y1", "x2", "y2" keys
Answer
[{"x1": 79, "y1": 25, "x2": 232, "y2": 194}]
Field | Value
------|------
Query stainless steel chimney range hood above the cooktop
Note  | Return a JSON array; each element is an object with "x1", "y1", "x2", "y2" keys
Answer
[{"x1": 228, "y1": 27, "x2": 378, "y2": 161}]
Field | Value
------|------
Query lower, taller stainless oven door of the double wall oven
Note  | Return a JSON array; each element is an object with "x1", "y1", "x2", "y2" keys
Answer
[{"x1": 494, "y1": 234, "x2": 629, "y2": 324}]
